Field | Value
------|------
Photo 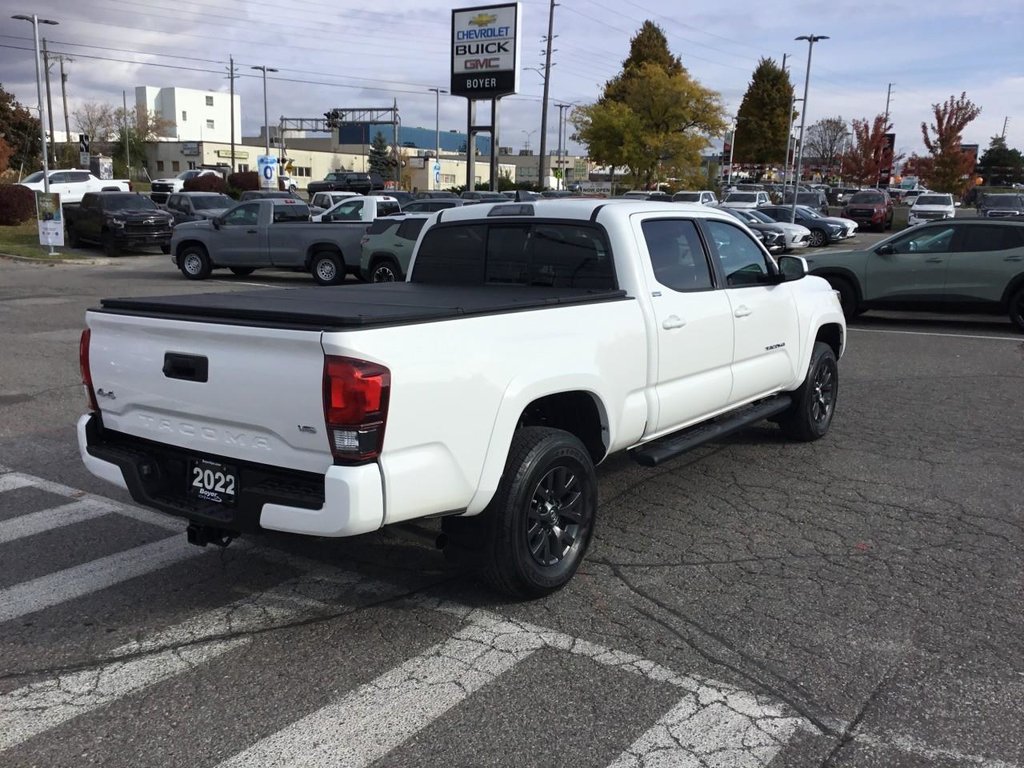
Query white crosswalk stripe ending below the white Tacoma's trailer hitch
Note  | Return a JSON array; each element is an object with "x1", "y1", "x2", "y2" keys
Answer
[{"x1": 0, "y1": 537, "x2": 204, "y2": 622}]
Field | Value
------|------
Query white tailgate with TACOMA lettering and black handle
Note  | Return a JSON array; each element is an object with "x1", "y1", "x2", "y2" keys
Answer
[{"x1": 86, "y1": 311, "x2": 332, "y2": 474}]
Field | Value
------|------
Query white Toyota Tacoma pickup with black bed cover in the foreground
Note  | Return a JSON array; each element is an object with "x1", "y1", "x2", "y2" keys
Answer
[{"x1": 78, "y1": 200, "x2": 846, "y2": 597}]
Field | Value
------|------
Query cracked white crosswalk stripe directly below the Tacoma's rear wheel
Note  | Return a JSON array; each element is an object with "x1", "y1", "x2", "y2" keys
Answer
[{"x1": 220, "y1": 621, "x2": 544, "y2": 768}]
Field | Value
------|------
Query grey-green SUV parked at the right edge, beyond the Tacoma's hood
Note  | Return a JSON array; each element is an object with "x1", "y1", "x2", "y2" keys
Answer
[{"x1": 807, "y1": 218, "x2": 1024, "y2": 332}]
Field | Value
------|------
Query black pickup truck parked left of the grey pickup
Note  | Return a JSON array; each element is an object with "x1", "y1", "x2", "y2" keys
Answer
[{"x1": 65, "y1": 191, "x2": 174, "y2": 256}]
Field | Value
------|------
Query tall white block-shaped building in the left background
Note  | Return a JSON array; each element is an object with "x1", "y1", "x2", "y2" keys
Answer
[{"x1": 135, "y1": 85, "x2": 242, "y2": 142}]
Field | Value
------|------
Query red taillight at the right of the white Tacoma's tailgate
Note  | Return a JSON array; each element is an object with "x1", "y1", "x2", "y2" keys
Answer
[{"x1": 324, "y1": 355, "x2": 391, "y2": 464}]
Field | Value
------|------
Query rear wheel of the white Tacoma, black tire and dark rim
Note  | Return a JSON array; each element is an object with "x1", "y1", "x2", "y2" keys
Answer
[{"x1": 445, "y1": 427, "x2": 597, "y2": 598}]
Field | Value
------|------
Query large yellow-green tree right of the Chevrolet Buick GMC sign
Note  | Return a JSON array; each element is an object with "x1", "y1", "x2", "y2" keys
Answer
[{"x1": 570, "y1": 22, "x2": 725, "y2": 186}]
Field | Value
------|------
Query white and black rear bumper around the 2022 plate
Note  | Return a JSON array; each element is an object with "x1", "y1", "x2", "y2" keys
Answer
[{"x1": 78, "y1": 414, "x2": 384, "y2": 537}]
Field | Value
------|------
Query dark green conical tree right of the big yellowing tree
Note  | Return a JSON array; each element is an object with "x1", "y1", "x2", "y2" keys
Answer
[{"x1": 732, "y1": 58, "x2": 793, "y2": 165}]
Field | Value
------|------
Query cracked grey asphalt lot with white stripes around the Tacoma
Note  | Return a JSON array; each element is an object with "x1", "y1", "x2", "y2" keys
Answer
[{"x1": 0, "y1": 256, "x2": 1024, "y2": 768}]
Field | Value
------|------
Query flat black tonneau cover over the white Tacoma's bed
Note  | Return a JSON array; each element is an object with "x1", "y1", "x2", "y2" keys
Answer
[{"x1": 94, "y1": 283, "x2": 628, "y2": 331}]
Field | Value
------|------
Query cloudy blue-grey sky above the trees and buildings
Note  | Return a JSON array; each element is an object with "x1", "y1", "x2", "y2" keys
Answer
[{"x1": 0, "y1": 0, "x2": 1024, "y2": 159}]
